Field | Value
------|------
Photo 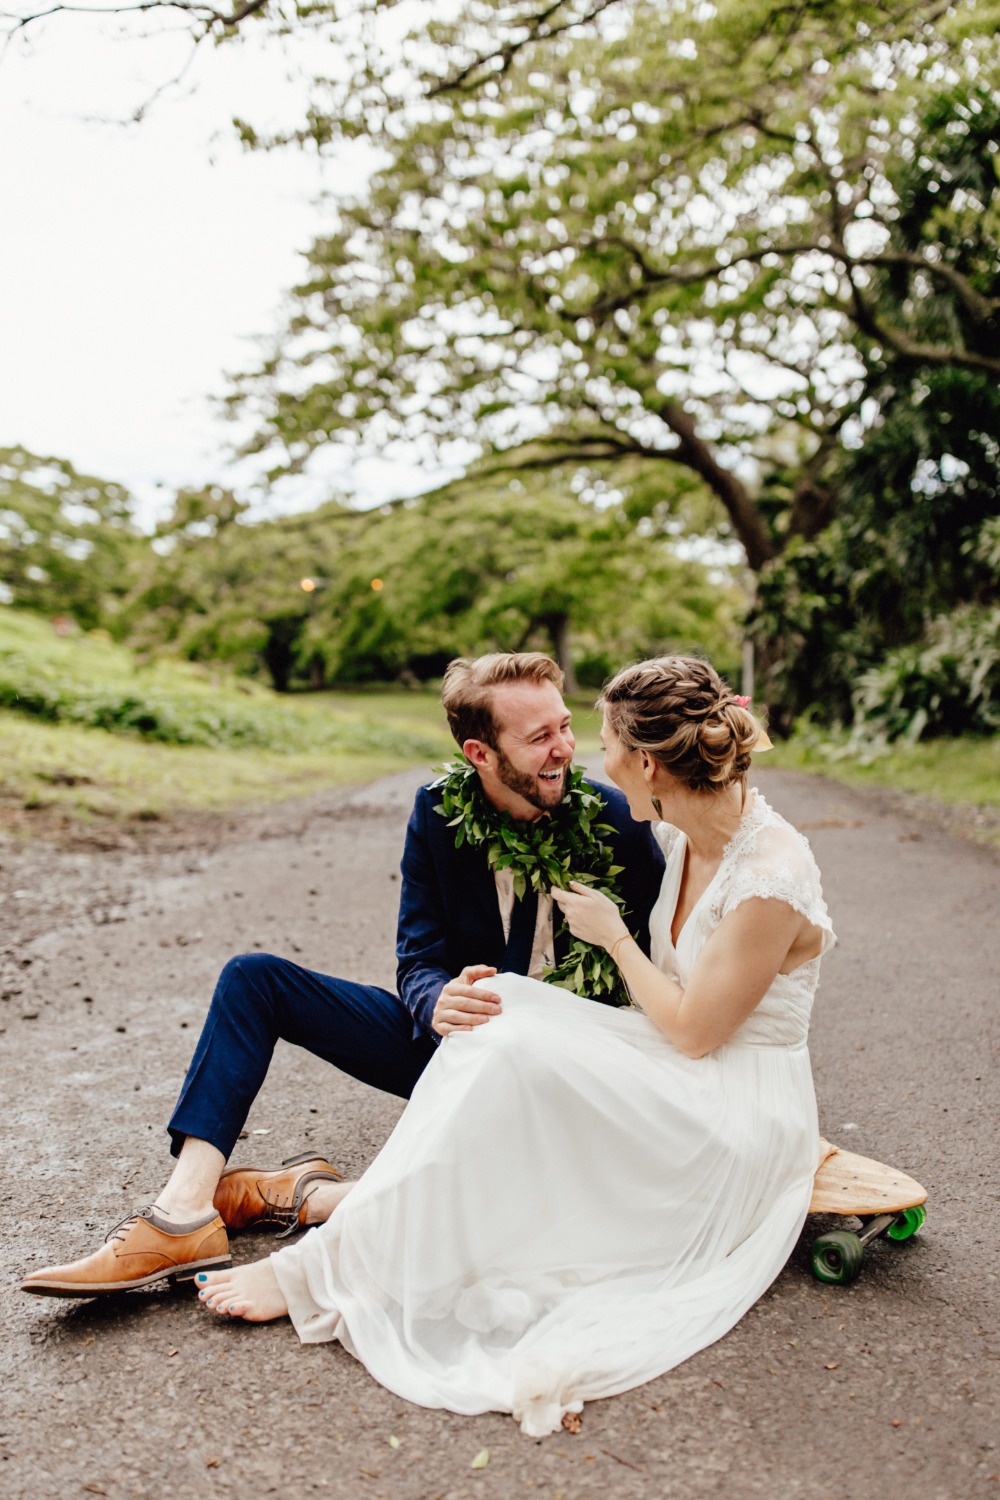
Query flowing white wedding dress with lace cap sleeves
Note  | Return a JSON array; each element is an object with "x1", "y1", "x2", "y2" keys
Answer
[{"x1": 271, "y1": 794, "x2": 834, "y2": 1437}]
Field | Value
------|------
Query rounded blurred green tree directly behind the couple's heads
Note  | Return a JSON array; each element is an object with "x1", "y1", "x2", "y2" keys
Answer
[{"x1": 296, "y1": 474, "x2": 739, "y2": 687}]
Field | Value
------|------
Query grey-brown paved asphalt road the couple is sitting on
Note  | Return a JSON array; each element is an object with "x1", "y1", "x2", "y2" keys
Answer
[{"x1": 0, "y1": 773, "x2": 1000, "y2": 1500}]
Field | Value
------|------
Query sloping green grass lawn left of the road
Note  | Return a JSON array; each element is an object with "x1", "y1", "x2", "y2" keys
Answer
[{"x1": 0, "y1": 609, "x2": 451, "y2": 833}]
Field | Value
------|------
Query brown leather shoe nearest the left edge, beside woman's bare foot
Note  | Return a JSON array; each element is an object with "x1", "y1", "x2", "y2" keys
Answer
[{"x1": 21, "y1": 1206, "x2": 232, "y2": 1298}]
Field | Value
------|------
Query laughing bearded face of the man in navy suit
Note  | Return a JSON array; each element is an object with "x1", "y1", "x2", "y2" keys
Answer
[{"x1": 480, "y1": 683, "x2": 576, "y2": 821}]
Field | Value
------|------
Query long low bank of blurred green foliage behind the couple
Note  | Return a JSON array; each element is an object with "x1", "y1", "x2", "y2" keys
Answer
[{"x1": 115, "y1": 474, "x2": 739, "y2": 687}]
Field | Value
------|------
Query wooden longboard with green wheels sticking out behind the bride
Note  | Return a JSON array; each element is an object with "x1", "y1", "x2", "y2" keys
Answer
[{"x1": 810, "y1": 1140, "x2": 927, "y2": 1286}]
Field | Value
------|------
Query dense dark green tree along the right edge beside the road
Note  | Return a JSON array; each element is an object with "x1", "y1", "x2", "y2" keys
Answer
[{"x1": 753, "y1": 84, "x2": 1000, "y2": 732}]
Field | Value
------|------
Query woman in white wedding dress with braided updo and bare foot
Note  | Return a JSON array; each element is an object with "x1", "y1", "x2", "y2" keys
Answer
[{"x1": 198, "y1": 657, "x2": 834, "y2": 1437}]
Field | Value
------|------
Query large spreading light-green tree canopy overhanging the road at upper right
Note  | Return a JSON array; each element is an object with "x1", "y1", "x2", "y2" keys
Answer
[{"x1": 226, "y1": 0, "x2": 1000, "y2": 570}]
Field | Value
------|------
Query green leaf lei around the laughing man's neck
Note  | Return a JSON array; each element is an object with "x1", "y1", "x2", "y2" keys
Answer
[{"x1": 432, "y1": 756, "x2": 631, "y2": 1005}]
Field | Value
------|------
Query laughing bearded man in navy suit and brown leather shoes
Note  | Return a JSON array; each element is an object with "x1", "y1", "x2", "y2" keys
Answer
[{"x1": 22, "y1": 653, "x2": 663, "y2": 1298}]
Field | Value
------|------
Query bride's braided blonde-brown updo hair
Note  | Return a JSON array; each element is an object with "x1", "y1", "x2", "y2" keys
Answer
[{"x1": 598, "y1": 656, "x2": 760, "y2": 792}]
